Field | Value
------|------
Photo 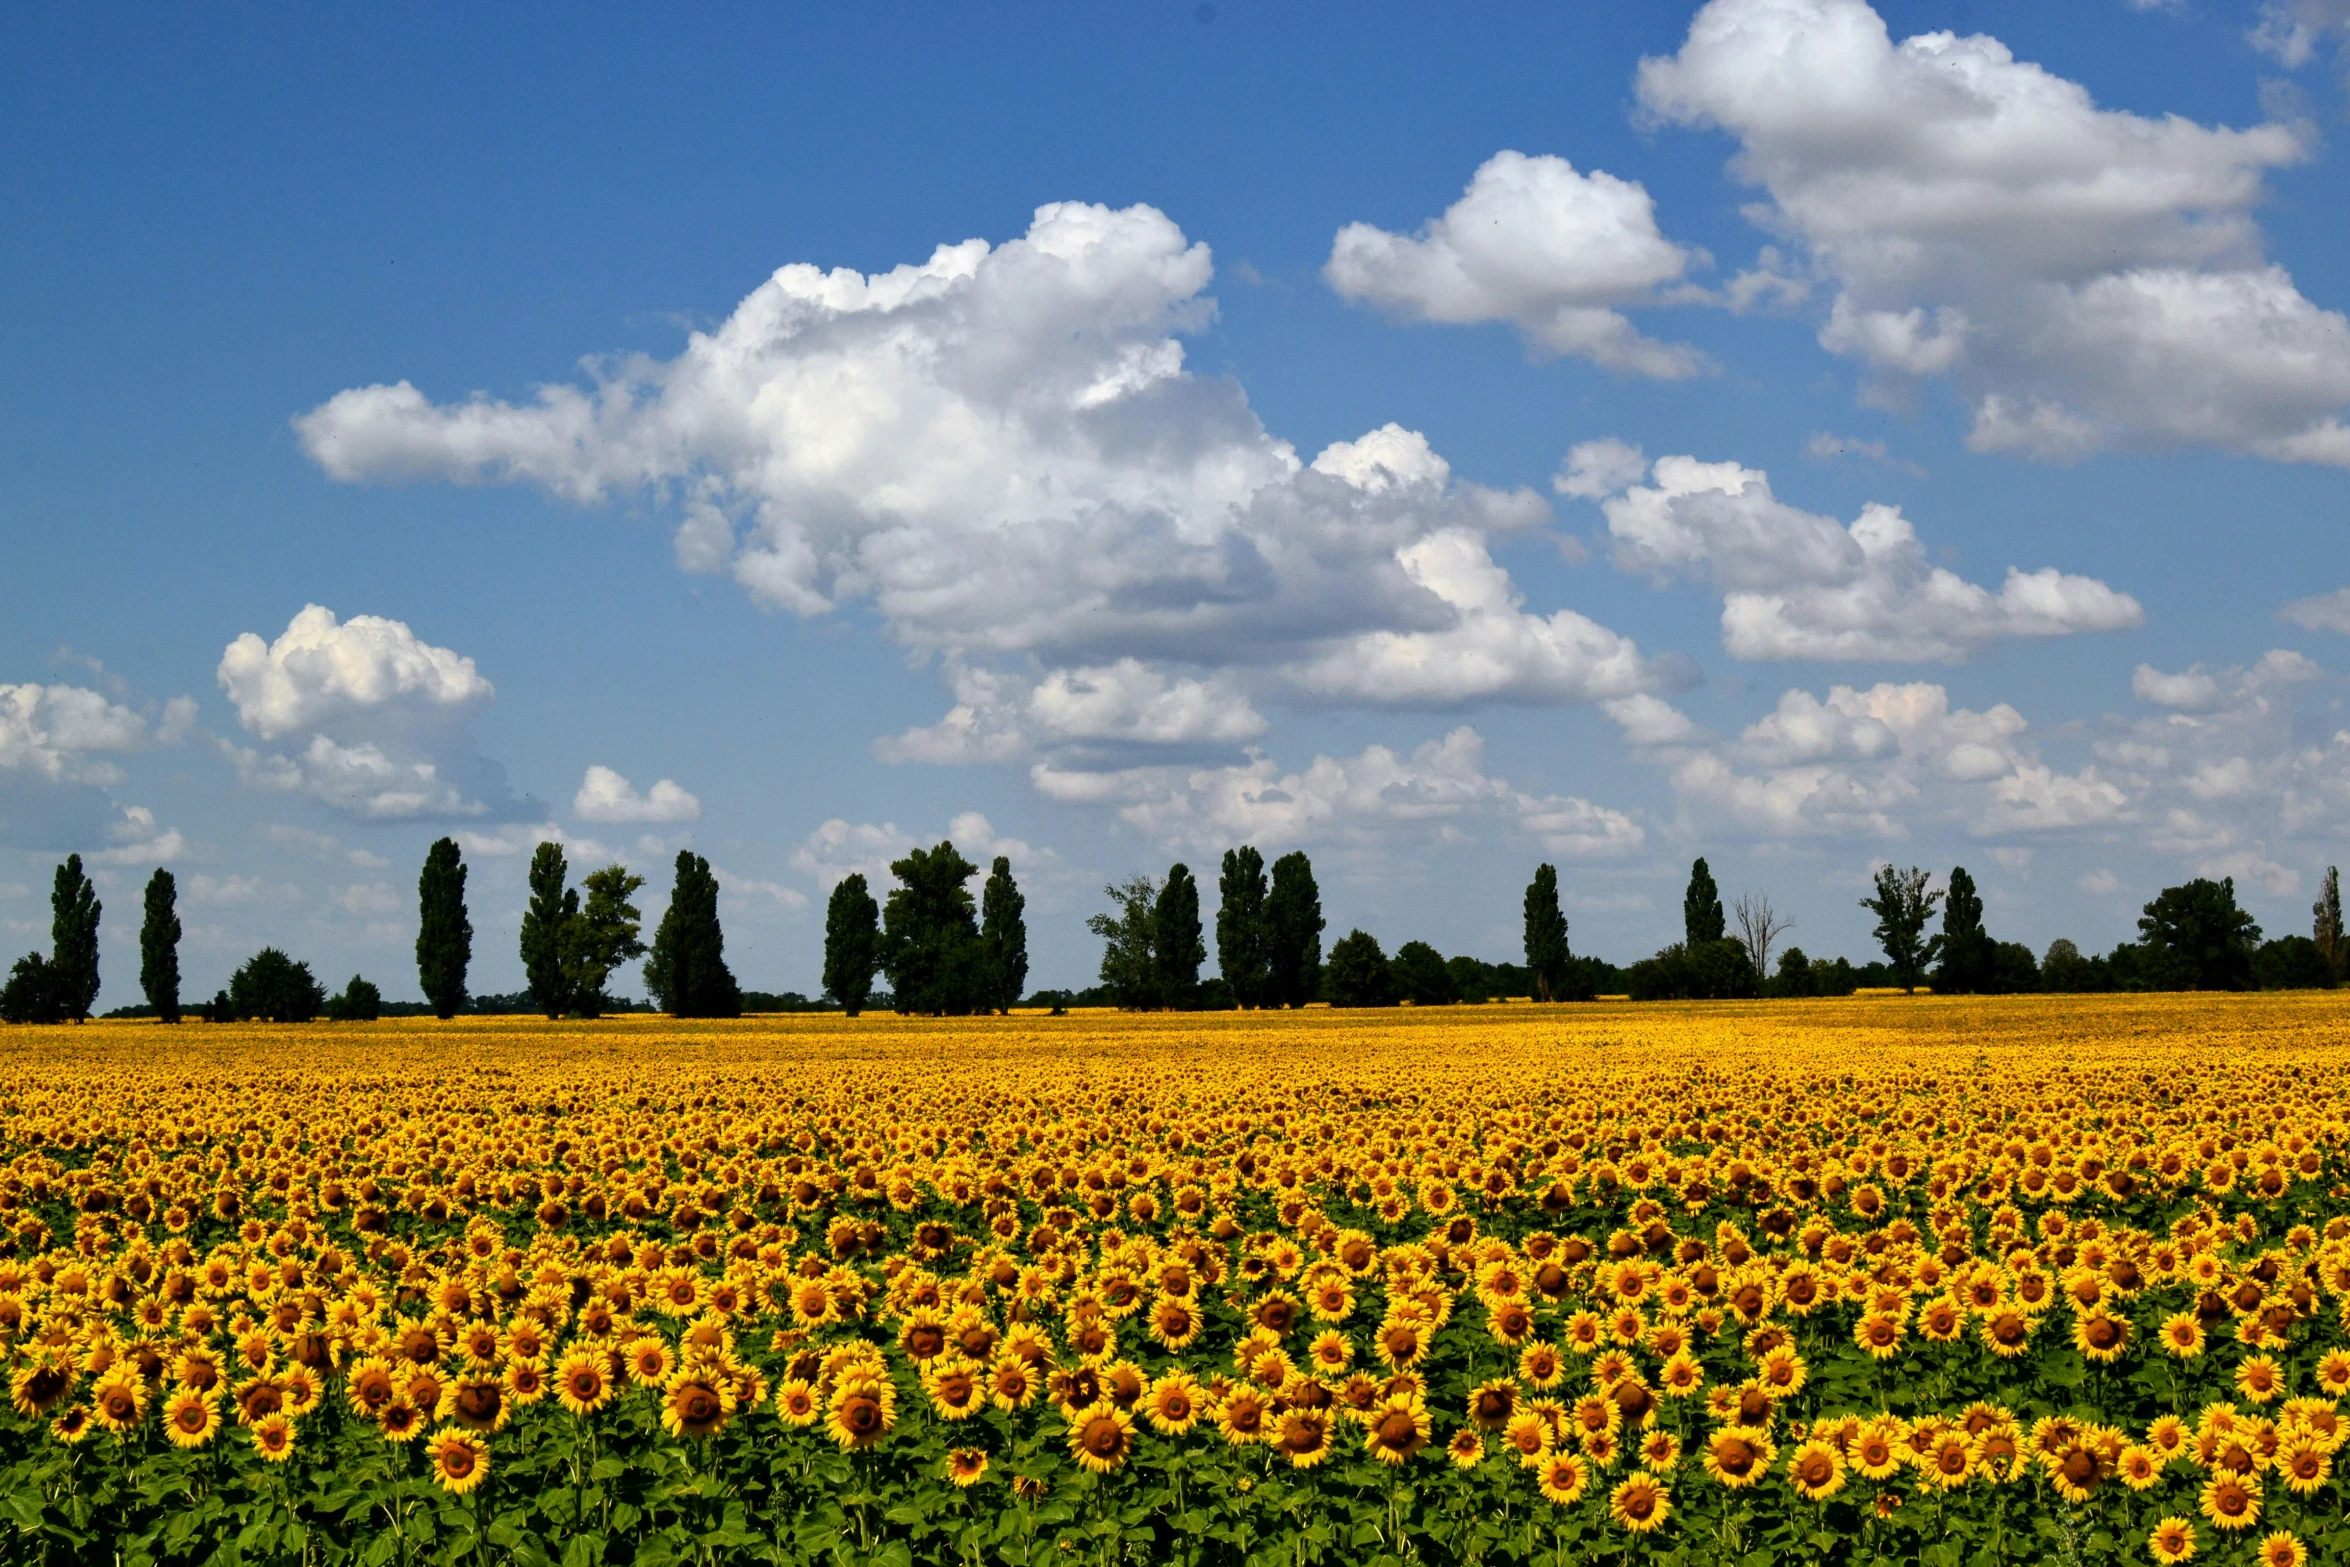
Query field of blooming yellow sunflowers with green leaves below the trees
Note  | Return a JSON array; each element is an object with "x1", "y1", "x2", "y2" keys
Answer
[{"x1": 0, "y1": 994, "x2": 2350, "y2": 1567}]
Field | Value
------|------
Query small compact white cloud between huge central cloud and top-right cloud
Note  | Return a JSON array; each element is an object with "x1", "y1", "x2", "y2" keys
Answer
[{"x1": 1323, "y1": 153, "x2": 1708, "y2": 378}]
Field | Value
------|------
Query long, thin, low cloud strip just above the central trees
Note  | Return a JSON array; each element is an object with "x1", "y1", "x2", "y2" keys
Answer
[{"x1": 1032, "y1": 728, "x2": 1645, "y2": 858}]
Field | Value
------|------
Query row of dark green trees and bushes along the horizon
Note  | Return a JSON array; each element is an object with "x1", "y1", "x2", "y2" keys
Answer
[{"x1": 0, "y1": 839, "x2": 2350, "y2": 1022}]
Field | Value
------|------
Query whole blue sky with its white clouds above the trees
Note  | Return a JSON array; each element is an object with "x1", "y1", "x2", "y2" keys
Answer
[{"x1": 0, "y1": 0, "x2": 2350, "y2": 1006}]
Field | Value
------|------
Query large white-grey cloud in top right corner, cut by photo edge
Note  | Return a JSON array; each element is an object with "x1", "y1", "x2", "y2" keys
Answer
[{"x1": 1638, "y1": 0, "x2": 2350, "y2": 465}]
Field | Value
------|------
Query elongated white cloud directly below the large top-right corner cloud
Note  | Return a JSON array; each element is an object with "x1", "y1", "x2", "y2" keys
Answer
[{"x1": 1560, "y1": 442, "x2": 2143, "y2": 663}]
